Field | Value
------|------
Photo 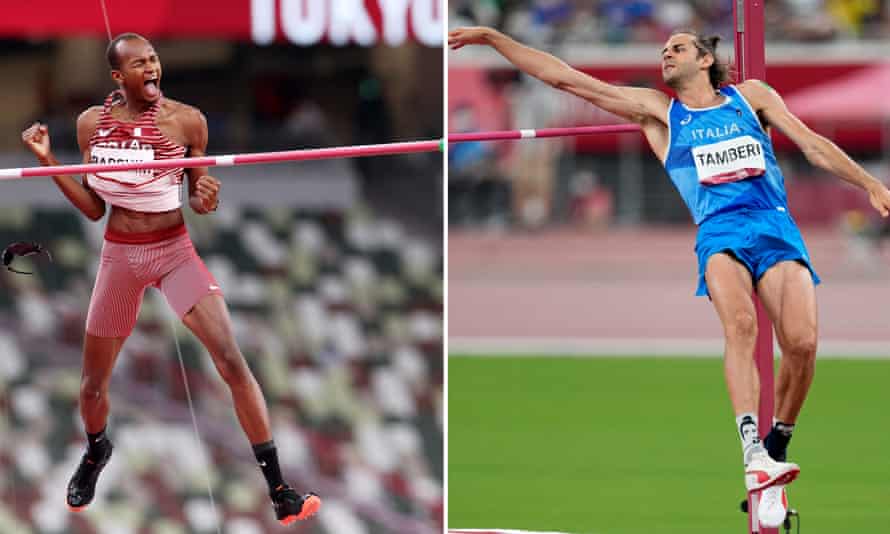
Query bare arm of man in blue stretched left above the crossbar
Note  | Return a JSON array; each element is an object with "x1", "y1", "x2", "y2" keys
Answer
[{"x1": 448, "y1": 27, "x2": 670, "y2": 124}]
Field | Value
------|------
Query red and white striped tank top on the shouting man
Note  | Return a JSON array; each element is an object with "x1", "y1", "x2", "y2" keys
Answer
[{"x1": 87, "y1": 91, "x2": 186, "y2": 212}]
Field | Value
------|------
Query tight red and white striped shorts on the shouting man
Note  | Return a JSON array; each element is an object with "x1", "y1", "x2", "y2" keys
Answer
[{"x1": 86, "y1": 225, "x2": 222, "y2": 337}]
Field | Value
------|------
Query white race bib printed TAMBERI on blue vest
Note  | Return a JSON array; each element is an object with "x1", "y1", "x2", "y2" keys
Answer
[{"x1": 692, "y1": 135, "x2": 766, "y2": 185}]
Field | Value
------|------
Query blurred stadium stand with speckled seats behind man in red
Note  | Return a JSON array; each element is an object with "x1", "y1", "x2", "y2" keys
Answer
[{"x1": 0, "y1": 0, "x2": 444, "y2": 534}]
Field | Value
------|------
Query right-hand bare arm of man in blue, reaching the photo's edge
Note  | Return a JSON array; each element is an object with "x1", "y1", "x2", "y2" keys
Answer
[{"x1": 739, "y1": 80, "x2": 890, "y2": 217}]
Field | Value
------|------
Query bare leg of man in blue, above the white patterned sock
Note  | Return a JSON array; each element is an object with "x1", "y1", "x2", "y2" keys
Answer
[{"x1": 705, "y1": 253, "x2": 760, "y2": 416}]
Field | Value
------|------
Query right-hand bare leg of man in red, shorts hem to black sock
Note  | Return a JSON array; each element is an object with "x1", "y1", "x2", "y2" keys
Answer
[{"x1": 182, "y1": 294, "x2": 272, "y2": 445}]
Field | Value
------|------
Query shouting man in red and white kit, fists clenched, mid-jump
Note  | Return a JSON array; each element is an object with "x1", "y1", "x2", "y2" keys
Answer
[{"x1": 22, "y1": 33, "x2": 321, "y2": 524}]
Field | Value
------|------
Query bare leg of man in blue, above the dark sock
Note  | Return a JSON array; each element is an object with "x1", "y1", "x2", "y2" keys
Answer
[{"x1": 757, "y1": 261, "x2": 818, "y2": 424}]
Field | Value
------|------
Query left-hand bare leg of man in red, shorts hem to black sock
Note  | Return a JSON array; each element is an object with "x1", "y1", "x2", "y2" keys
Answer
[{"x1": 80, "y1": 334, "x2": 126, "y2": 434}]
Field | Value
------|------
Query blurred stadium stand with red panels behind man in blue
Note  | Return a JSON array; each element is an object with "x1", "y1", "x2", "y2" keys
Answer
[{"x1": 449, "y1": 0, "x2": 890, "y2": 236}]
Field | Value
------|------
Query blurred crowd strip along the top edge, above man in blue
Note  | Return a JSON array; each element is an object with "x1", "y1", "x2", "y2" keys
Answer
[{"x1": 449, "y1": 0, "x2": 890, "y2": 45}]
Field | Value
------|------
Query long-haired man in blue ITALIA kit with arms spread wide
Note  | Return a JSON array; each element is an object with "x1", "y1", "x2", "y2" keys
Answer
[{"x1": 448, "y1": 28, "x2": 890, "y2": 527}]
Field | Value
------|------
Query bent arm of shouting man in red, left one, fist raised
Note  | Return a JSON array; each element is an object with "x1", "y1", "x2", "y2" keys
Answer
[{"x1": 22, "y1": 108, "x2": 105, "y2": 221}]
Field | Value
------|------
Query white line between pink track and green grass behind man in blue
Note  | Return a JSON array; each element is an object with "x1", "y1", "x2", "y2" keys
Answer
[{"x1": 448, "y1": 337, "x2": 890, "y2": 360}]
